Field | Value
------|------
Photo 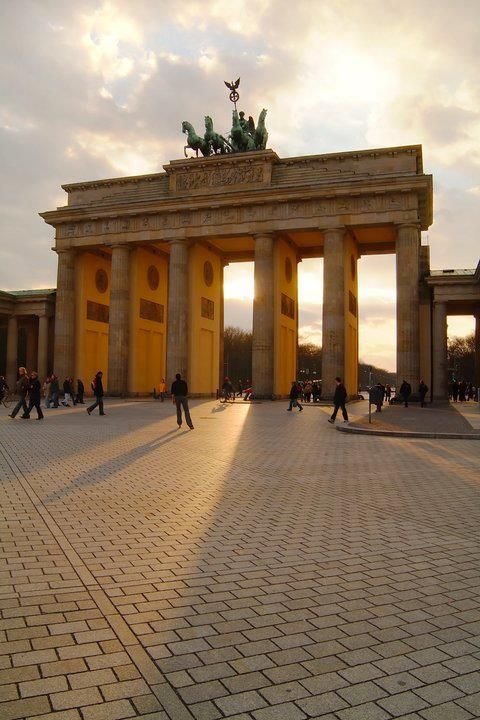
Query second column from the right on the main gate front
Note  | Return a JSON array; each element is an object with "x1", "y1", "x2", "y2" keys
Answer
[{"x1": 322, "y1": 228, "x2": 344, "y2": 399}]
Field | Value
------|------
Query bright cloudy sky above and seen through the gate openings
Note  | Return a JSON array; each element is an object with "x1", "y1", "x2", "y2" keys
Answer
[{"x1": 0, "y1": 0, "x2": 480, "y2": 369}]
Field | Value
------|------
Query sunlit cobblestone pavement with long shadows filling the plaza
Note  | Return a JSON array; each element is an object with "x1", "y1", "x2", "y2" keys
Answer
[{"x1": 0, "y1": 402, "x2": 480, "y2": 720}]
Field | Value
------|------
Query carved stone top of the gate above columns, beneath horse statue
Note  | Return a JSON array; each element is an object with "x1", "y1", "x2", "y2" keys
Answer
[{"x1": 41, "y1": 146, "x2": 432, "y2": 252}]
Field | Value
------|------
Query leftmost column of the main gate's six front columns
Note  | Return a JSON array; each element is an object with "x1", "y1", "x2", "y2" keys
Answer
[{"x1": 53, "y1": 249, "x2": 75, "y2": 385}]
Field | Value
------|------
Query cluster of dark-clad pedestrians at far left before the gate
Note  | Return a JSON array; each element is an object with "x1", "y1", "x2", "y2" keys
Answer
[{"x1": 5, "y1": 367, "x2": 105, "y2": 420}]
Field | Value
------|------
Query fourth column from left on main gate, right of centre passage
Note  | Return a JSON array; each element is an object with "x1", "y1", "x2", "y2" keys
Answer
[{"x1": 252, "y1": 234, "x2": 274, "y2": 399}]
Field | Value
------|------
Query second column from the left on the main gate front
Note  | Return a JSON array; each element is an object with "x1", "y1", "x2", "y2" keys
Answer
[{"x1": 107, "y1": 243, "x2": 130, "y2": 395}]
